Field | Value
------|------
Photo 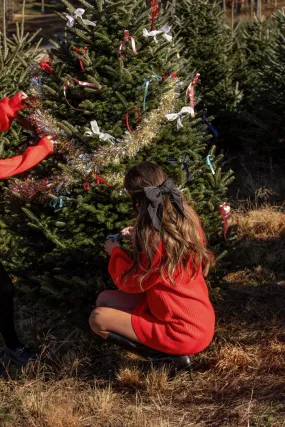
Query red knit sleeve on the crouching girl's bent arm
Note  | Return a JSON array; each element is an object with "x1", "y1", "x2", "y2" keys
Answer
[{"x1": 109, "y1": 247, "x2": 162, "y2": 294}]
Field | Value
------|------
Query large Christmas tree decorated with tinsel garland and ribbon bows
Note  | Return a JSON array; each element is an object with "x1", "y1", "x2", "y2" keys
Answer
[{"x1": 1, "y1": 0, "x2": 233, "y2": 314}]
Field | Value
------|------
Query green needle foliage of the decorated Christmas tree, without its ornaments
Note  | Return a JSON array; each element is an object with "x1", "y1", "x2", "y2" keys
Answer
[{"x1": 1, "y1": 0, "x2": 233, "y2": 313}]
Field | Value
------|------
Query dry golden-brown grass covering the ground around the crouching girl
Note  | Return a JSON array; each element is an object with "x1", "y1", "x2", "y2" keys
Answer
[{"x1": 0, "y1": 206, "x2": 285, "y2": 427}]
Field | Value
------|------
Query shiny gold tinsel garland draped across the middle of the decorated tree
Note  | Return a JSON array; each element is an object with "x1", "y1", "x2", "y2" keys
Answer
[{"x1": 27, "y1": 78, "x2": 178, "y2": 187}]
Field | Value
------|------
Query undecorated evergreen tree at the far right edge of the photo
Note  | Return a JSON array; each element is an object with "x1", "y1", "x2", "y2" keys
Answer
[{"x1": 217, "y1": 11, "x2": 284, "y2": 198}]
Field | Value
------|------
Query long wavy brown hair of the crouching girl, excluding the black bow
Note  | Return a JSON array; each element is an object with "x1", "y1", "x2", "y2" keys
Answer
[{"x1": 124, "y1": 162, "x2": 214, "y2": 286}]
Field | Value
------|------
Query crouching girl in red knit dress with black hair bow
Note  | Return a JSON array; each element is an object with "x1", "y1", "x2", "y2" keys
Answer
[{"x1": 90, "y1": 162, "x2": 215, "y2": 368}]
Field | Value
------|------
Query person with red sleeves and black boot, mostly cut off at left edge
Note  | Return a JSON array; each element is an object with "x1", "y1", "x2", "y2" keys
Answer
[{"x1": 0, "y1": 92, "x2": 53, "y2": 368}]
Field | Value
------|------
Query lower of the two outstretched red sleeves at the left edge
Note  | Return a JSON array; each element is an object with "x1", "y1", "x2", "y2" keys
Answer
[{"x1": 0, "y1": 137, "x2": 53, "y2": 179}]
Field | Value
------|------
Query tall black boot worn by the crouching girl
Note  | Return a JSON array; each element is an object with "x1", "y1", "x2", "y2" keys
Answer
[{"x1": 107, "y1": 332, "x2": 191, "y2": 371}]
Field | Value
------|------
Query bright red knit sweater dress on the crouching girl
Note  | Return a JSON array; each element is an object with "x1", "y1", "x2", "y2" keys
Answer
[{"x1": 109, "y1": 244, "x2": 215, "y2": 355}]
